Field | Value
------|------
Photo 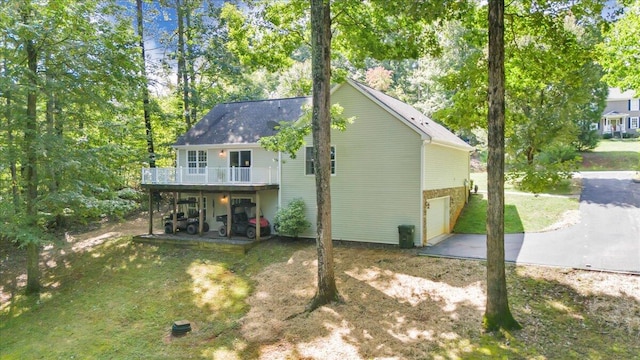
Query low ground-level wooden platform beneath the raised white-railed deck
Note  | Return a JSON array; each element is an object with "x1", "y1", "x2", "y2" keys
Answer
[{"x1": 133, "y1": 232, "x2": 269, "y2": 255}]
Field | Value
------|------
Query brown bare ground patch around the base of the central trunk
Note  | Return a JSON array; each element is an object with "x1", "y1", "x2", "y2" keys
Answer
[{"x1": 242, "y1": 247, "x2": 485, "y2": 359}]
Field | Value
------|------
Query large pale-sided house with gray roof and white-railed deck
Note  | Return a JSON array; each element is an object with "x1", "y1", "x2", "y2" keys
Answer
[{"x1": 142, "y1": 80, "x2": 473, "y2": 246}]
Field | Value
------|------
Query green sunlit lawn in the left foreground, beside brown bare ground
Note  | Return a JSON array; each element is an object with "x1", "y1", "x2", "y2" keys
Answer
[{"x1": 0, "y1": 237, "x2": 308, "y2": 359}]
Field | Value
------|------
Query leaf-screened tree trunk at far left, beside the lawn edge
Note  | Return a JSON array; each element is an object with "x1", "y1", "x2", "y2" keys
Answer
[{"x1": 22, "y1": 2, "x2": 40, "y2": 294}]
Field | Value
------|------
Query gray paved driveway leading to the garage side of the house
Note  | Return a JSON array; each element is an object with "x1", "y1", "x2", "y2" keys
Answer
[{"x1": 420, "y1": 171, "x2": 640, "y2": 274}]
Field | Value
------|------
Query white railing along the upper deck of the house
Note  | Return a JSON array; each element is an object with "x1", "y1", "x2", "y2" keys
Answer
[{"x1": 142, "y1": 167, "x2": 280, "y2": 185}]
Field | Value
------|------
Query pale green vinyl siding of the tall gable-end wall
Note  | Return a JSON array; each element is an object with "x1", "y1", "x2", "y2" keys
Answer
[{"x1": 281, "y1": 85, "x2": 422, "y2": 244}]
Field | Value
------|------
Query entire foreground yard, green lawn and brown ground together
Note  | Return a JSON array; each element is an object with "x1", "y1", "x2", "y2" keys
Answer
[{"x1": 0, "y1": 224, "x2": 640, "y2": 360}]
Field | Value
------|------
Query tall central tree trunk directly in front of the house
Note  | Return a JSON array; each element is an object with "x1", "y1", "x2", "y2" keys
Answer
[{"x1": 307, "y1": 0, "x2": 339, "y2": 311}]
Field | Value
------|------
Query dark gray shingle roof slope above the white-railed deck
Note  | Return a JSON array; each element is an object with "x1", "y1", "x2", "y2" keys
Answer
[{"x1": 174, "y1": 97, "x2": 311, "y2": 146}]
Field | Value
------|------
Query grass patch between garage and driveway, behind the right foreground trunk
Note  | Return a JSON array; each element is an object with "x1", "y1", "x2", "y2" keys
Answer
[{"x1": 453, "y1": 193, "x2": 579, "y2": 234}]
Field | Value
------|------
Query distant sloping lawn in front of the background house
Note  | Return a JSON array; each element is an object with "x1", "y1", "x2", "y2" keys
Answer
[{"x1": 580, "y1": 139, "x2": 640, "y2": 171}]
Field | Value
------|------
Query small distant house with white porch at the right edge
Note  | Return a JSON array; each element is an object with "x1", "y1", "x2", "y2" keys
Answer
[{"x1": 596, "y1": 88, "x2": 640, "y2": 137}]
